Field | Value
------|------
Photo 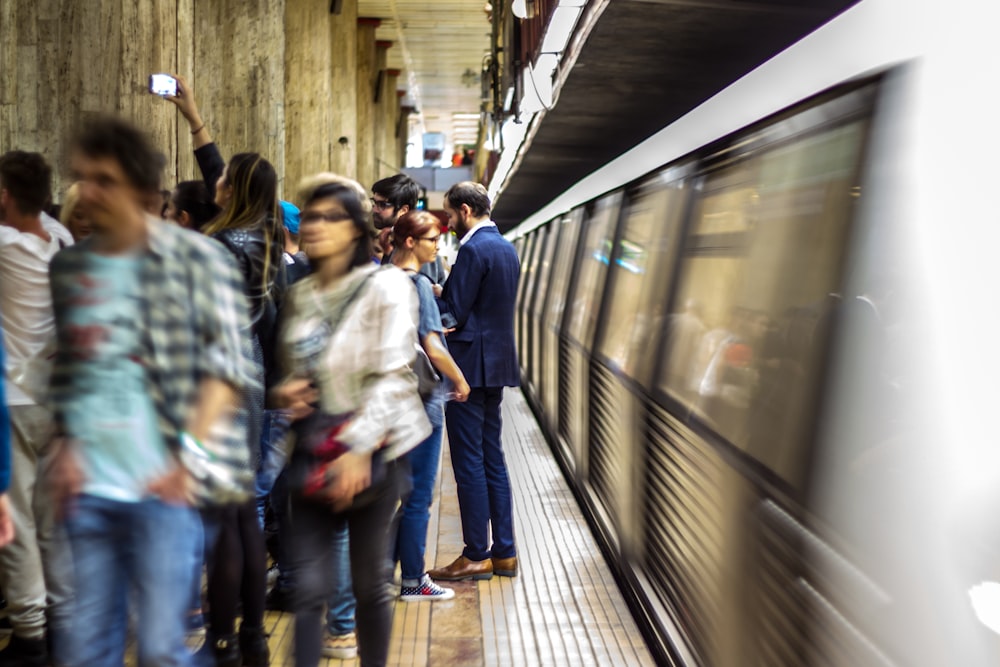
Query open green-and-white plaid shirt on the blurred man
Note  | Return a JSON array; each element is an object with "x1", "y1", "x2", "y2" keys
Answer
[{"x1": 49, "y1": 217, "x2": 255, "y2": 470}]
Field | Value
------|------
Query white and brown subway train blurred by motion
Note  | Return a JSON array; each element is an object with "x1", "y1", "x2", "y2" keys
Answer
[{"x1": 501, "y1": 0, "x2": 1000, "y2": 667}]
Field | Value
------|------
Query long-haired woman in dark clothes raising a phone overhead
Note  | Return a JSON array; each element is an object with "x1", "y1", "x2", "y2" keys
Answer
[{"x1": 166, "y1": 70, "x2": 286, "y2": 667}]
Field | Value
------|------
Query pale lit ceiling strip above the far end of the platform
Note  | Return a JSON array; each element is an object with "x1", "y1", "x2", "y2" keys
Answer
[{"x1": 358, "y1": 0, "x2": 490, "y2": 151}]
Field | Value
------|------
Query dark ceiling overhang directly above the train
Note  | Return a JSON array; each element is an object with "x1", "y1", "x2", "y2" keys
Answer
[{"x1": 493, "y1": 0, "x2": 854, "y2": 230}]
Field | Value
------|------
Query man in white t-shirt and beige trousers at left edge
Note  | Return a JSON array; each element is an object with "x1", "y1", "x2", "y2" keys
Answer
[{"x1": 0, "y1": 151, "x2": 73, "y2": 667}]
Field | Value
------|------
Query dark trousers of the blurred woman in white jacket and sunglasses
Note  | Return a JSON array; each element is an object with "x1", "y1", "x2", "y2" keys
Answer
[{"x1": 290, "y1": 461, "x2": 405, "y2": 667}]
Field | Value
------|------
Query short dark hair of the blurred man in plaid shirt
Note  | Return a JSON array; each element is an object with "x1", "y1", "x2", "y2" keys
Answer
[{"x1": 72, "y1": 116, "x2": 166, "y2": 192}]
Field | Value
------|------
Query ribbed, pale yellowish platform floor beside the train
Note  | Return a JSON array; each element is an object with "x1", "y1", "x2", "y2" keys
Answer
[{"x1": 266, "y1": 389, "x2": 654, "y2": 667}]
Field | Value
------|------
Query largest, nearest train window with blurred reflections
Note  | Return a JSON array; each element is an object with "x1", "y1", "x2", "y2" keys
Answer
[{"x1": 660, "y1": 121, "x2": 865, "y2": 485}]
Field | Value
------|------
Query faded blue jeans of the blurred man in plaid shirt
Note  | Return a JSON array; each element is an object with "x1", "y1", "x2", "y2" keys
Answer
[{"x1": 66, "y1": 495, "x2": 197, "y2": 667}]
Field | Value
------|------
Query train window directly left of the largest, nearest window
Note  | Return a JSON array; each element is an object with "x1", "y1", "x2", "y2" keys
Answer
[{"x1": 596, "y1": 169, "x2": 687, "y2": 386}]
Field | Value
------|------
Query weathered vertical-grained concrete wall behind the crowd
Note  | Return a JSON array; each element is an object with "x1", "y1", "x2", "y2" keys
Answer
[{"x1": 0, "y1": 0, "x2": 399, "y2": 201}]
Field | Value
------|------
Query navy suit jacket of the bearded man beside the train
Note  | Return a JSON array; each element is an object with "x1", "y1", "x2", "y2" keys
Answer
[{"x1": 441, "y1": 227, "x2": 521, "y2": 387}]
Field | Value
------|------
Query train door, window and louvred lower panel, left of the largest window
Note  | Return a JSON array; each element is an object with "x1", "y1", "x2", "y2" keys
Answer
[{"x1": 587, "y1": 167, "x2": 690, "y2": 554}]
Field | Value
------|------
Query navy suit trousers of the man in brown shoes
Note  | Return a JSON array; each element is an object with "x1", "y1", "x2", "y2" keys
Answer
[{"x1": 445, "y1": 387, "x2": 517, "y2": 560}]
